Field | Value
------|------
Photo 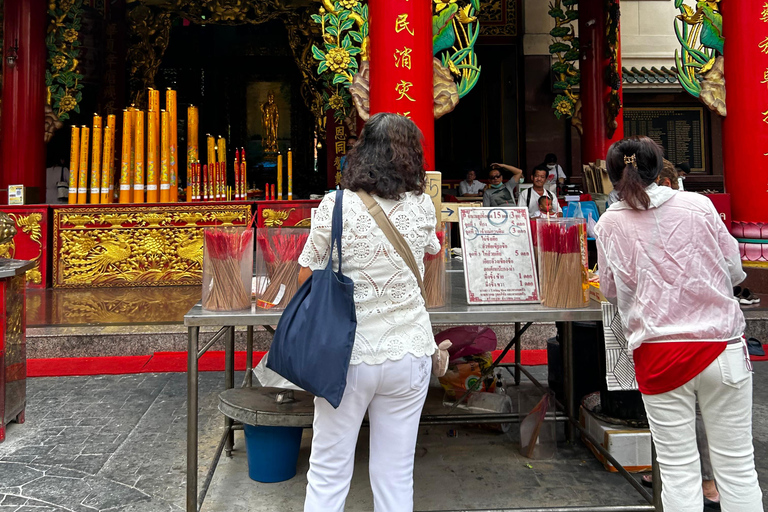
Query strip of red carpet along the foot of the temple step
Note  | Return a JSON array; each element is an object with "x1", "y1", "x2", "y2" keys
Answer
[{"x1": 27, "y1": 350, "x2": 547, "y2": 377}]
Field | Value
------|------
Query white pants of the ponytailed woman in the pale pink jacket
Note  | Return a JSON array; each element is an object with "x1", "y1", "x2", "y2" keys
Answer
[{"x1": 643, "y1": 343, "x2": 763, "y2": 512}]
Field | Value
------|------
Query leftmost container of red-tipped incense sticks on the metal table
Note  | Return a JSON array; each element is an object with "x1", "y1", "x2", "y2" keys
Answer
[{"x1": 203, "y1": 228, "x2": 253, "y2": 311}]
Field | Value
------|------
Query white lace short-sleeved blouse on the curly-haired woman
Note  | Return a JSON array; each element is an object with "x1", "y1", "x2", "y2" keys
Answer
[{"x1": 299, "y1": 190, "x2": 440, "y2": 365}]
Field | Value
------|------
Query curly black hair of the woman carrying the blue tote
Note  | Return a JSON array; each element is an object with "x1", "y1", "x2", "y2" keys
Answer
[{"x1": 341, "y1": 112, "x2": 427, "y2": 201}]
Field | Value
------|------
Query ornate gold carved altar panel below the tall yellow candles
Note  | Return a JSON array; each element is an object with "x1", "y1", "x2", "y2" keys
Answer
[{"x1": 53, "y1": 204, "x2": 251, "y2": 288}]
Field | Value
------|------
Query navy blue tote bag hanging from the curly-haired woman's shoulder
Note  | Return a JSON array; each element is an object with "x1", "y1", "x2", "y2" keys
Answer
[{"x1": 267, "y1": 190, "x2": 357, "y2": 408}]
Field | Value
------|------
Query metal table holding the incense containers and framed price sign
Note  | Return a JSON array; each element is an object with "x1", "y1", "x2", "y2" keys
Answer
[{"x1": 184, "y1": 272, "x2": 768, "y2": 512}]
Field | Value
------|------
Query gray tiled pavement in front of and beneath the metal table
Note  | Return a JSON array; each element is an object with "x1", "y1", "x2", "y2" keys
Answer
[{"x1": 0, "y1": 363, "x2": 768, "y2": 512}]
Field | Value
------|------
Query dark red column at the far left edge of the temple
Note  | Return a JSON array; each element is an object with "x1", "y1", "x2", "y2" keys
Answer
[{"x1": 0, "y1": 0, "x2": 47, "y2": 202}]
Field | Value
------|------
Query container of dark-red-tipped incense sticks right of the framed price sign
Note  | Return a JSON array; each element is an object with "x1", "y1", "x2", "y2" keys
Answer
[{"x1": 536, "y1": 218, "x2": 589, "y2": 308}]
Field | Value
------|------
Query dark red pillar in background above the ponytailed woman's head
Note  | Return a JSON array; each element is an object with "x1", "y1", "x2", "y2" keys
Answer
[{"x1": 579, "y1": 0, "x2": 624, "y2": 164}]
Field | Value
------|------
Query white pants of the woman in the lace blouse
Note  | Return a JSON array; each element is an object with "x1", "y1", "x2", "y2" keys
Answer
[{"x1": 304, "y1": 355, "x2": 432, "y2": 512}]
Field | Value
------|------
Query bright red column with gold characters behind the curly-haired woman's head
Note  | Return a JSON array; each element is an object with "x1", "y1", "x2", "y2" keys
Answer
[{"x1": 368, "y1": 0, "x2": 435, "y2": 170}]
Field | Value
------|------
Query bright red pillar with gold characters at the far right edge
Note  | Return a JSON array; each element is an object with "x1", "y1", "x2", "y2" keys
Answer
[{"x1": 722, "y1": 2, "x2": 768, "y2": 248}]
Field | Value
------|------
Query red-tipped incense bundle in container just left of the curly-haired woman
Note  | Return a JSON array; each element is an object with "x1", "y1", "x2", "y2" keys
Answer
[{"x1": 256, "y1": 228, "x2": 309, "y2": 308}]
